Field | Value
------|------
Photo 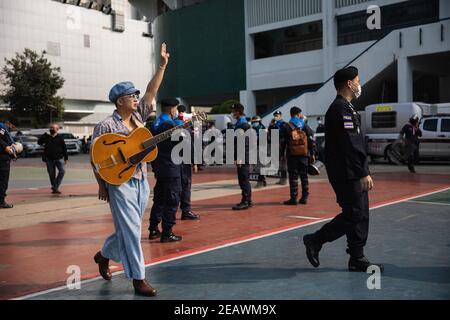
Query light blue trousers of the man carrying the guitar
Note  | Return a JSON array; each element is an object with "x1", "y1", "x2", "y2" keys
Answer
[{"x1": 102, "y1": 178, "x2": 150, "y2": 280}]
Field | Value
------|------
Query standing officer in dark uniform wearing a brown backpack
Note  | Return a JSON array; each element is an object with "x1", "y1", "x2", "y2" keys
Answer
[{"x1": 282, "y1": 107, "x2": 314, "y2": 206}]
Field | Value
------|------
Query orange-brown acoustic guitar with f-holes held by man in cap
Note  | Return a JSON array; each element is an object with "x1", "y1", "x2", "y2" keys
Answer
[{"x1": 91, "y1": 114, "x2": 206, "y2": 186}]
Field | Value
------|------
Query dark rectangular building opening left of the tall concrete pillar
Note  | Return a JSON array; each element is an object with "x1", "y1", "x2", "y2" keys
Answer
[{"x1": 254, "y1": 21, "x2": 322, "y2": 59}]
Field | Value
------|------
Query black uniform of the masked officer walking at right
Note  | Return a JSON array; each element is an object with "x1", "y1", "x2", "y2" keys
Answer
[{"x1": 314, "y1": 96, "x2": 370, "y2": 258}]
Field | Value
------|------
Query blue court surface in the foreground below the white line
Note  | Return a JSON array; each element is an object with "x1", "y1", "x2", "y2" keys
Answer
[{"x1": 24, "y1": 190, "x2": 450, "y2": 300}]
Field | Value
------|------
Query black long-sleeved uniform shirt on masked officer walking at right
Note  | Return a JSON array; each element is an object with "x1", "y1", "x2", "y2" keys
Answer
[{"x1": 325, "y1": 95, "x2": 370, "y2": 182}]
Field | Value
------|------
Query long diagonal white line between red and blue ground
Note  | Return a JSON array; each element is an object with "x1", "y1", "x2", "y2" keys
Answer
[{"x1": 11, "y1": 187, "x2": 450, "y2": 300}]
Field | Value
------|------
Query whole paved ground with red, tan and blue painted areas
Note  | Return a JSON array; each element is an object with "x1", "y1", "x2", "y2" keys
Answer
[{"x1": 0, "y1": 156, "x2": 450, "y2": 299}]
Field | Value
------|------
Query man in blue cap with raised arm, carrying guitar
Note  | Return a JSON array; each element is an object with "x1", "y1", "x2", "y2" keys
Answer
[{"x1": 92, "y1": 43, "x2": 170, "y2": 296}]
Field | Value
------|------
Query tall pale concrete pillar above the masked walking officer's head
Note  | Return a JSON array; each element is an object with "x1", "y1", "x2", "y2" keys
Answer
[{"x1": 322, "y1": 0, "x2": 337, "y2": 81}]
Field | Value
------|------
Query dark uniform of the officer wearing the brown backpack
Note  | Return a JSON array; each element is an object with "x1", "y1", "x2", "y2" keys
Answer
[{"x1": 283, "y1": 119, "x2": 314, "y2": 199}]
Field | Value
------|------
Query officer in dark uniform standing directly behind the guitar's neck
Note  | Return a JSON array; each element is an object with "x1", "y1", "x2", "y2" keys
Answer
[{"x1": 149, "y1": 99, "x2": 182, "y2": 243}]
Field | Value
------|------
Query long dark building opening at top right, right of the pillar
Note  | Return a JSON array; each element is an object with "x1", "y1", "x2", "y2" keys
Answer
[{"x1": 337, "y1": 0, "x2": 439, "y2": 46}]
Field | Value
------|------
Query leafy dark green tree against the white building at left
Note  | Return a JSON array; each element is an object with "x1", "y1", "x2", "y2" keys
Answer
[{"x1": 1, "y1": 49, "x2": 64, "y2": 127}]
